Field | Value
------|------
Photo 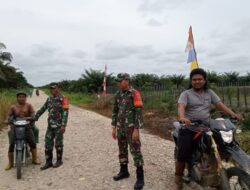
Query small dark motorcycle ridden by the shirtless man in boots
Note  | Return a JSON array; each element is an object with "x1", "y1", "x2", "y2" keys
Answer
[{"x1": 9, "y1": 118, "x2": 31, "y2": 179}]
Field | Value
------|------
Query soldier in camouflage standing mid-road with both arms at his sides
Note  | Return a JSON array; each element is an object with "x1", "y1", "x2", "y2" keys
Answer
[{"x1": 112, "y1": 73, "x2": 144, "y2": 190}]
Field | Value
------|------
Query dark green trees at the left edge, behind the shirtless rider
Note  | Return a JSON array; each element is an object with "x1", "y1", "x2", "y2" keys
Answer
[{"x1": 0, "y1": 42, "x2": 31, "y2": 89}]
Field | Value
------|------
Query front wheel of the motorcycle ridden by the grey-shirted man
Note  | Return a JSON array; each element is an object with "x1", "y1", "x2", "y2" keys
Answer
[{"x1": 227, "y1": 167, "x2": 250, "y2": 190}]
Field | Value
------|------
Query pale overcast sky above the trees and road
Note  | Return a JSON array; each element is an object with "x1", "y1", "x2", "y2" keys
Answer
[{"x1": 0, "y1": 0, "x2": 250, "y2": 85}]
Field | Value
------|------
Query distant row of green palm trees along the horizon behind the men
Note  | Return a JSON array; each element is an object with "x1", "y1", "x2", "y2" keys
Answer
[{"x1": 44, "y1": 69, "x2": 250, "y2": 93}]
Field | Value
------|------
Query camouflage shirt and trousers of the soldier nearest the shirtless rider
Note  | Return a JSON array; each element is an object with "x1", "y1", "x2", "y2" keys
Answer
[{"x1": 35, "y1": 95, "x2": 68, "y2": 160}]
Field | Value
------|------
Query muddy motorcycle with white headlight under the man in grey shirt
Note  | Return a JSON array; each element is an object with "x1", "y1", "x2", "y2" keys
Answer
[{"x1": 172, "y1": 118, "x2": 250, "y2": 190}]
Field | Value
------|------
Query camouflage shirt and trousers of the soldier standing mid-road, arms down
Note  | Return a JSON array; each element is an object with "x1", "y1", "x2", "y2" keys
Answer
[{"x1": 111, "y1": 88, "x2": 143, "y2": 167}]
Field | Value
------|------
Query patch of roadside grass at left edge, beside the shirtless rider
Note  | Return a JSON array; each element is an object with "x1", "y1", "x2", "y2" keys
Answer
[{"x1": 0, "y1": 90, "x2": 16, "y2": 129}]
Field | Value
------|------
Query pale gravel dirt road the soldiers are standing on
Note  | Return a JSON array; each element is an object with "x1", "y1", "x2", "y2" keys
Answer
[{"x1": 0, "y1": 93, "x2": 178, "y2": 190}]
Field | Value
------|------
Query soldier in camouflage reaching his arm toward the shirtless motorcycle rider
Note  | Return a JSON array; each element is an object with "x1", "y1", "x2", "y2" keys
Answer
[{"x1": 34, "y1": 83, "x2": 69, "y2": 170}]
